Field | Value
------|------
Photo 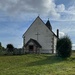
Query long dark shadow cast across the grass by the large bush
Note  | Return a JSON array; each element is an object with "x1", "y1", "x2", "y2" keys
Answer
[{"x1": 27, "y1": 55, "x2": 64, "y2": 67}]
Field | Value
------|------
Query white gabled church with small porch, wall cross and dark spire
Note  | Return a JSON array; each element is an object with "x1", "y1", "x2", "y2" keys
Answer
[{"x1": 23, "y1": 16, "x2": 59, "y2": 53}]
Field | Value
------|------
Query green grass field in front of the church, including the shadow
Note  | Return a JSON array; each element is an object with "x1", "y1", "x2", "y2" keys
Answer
[{"x1": 0, "y1": 54, "x2": 75, "y2": 75}]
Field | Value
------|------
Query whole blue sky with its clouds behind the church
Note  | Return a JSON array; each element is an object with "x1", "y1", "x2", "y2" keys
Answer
[{"x1": 0, "y1": 0, "x2": 75, "y2": 48}]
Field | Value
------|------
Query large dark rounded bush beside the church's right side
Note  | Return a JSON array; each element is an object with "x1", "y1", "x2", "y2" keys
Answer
[{"x1": 56, "y1": 36, "x2": 72, "y2": 58}]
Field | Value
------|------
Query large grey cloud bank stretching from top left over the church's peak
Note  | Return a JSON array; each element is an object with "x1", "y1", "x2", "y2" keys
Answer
[{"x1": 0, "y1": 0, "x2": 60, "y2": 18}]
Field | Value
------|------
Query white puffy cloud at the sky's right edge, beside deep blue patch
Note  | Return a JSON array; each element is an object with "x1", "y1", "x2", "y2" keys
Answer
[{"x1": 58, "y1": 5, "x2": 75, "y2": 21}]
